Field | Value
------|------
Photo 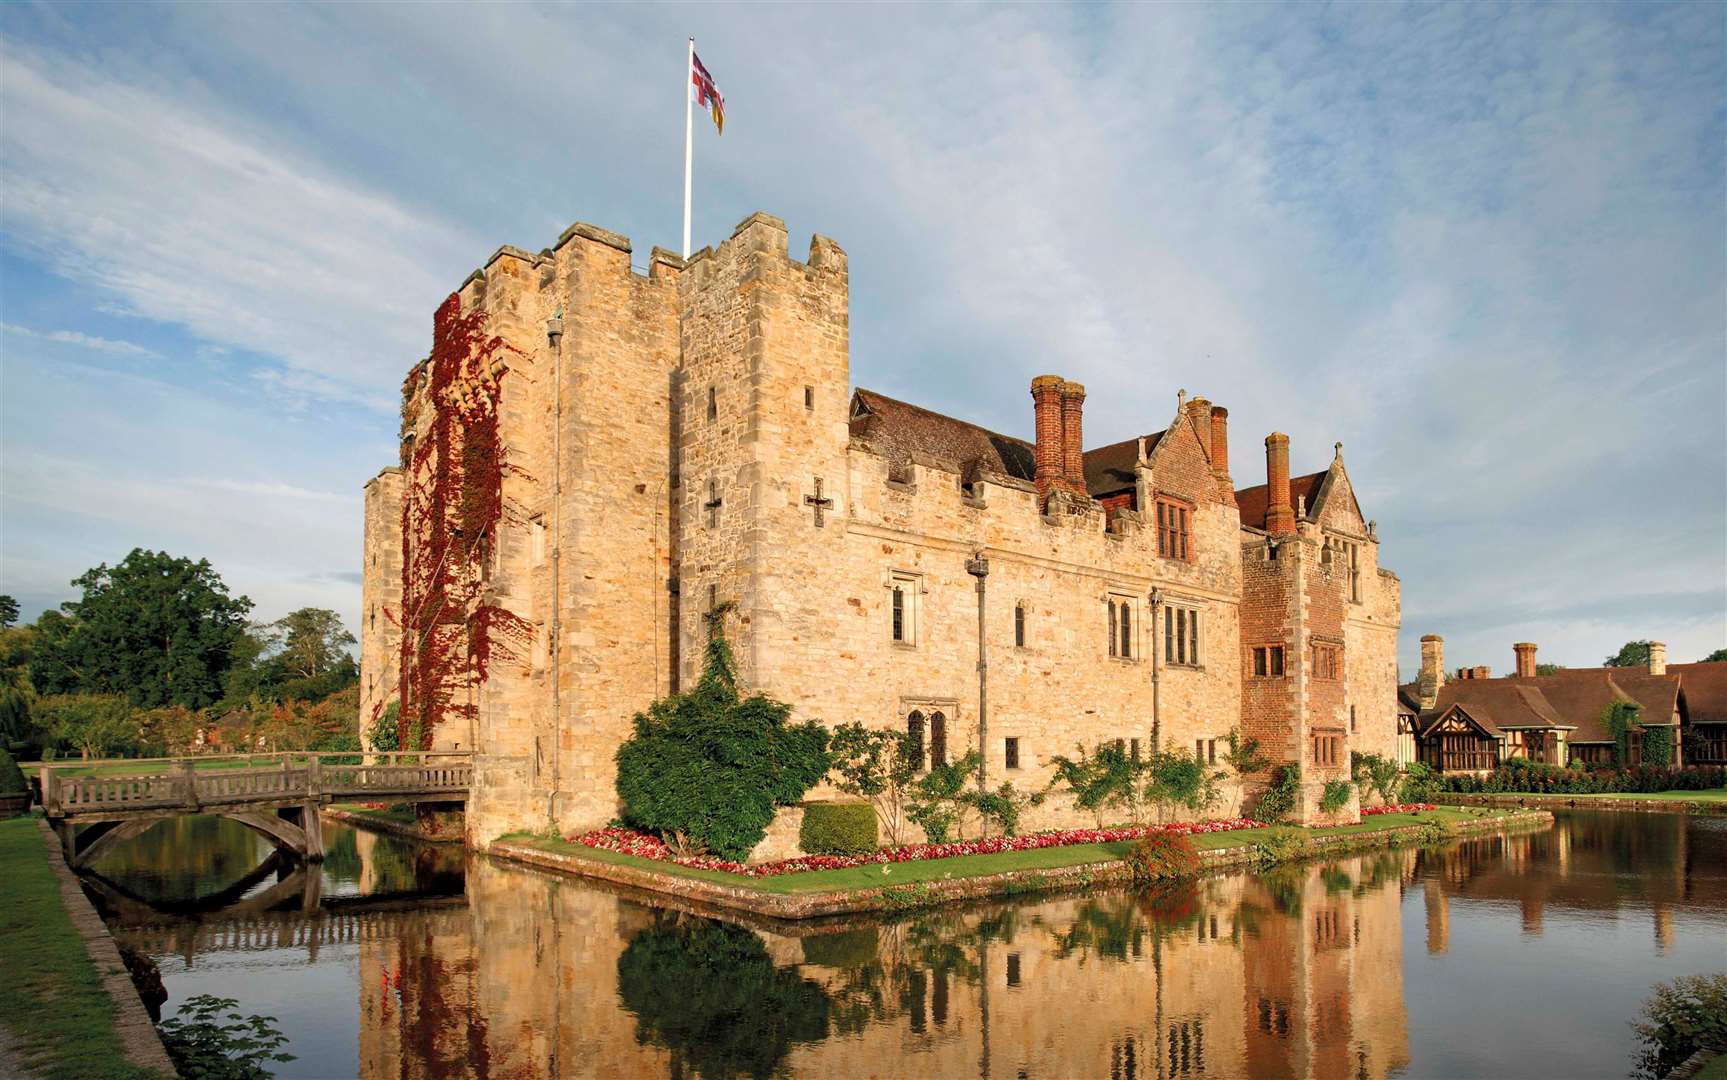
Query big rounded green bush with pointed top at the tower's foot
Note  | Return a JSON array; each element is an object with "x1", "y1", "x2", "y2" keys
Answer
[{"x1": 617, "y1": 605, "x2": 829, "y2": 861}]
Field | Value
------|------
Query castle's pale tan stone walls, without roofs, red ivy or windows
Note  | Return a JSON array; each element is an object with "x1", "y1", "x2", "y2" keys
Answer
[{"x1": 363, "y1": 206, "x2": 1397, "y2": 843}]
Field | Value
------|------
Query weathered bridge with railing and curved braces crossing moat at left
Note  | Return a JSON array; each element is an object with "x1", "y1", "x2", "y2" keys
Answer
[{"x1": 41, "y1": 752, "x2": 473, "y2": 869}]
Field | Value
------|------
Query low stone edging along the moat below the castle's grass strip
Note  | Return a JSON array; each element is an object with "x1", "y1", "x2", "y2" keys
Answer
[{"x1": 485, "y1": 810, "x2": 1553, "y2": 919}]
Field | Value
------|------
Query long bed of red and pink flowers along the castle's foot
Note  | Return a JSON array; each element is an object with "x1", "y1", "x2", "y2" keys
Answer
[{"x1": 568, "y1": 805, "x2": 1264, "y2": 878}]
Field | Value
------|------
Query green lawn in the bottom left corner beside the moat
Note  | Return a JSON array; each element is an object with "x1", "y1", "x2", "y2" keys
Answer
[{"x1": 0, "y1": 817, "x2": 155, "y2": 1078}]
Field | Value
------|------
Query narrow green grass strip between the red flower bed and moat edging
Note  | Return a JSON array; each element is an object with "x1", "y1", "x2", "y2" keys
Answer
[{"x1": 504, "y1": 807, "x2": 1490, "y2": 895}]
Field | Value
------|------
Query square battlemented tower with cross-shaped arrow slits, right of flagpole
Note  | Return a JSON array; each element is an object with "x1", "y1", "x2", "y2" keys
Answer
[{"x1": 677, "y1": 213, "x2": 851, "y2": 694}]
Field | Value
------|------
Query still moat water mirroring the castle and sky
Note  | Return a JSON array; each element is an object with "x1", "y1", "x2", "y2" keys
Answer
[{"x1": 98, "y1": 812, "x2": 1727, "y2": 1080}]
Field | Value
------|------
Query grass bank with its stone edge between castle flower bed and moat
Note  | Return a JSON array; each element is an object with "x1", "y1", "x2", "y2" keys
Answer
[{"x1": 492, "y1": 807, "x2": 1551, "y2": 918}]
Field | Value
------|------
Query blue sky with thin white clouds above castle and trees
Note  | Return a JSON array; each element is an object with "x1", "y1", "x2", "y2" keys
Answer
[{"x1": 0, "y1": 3, "x2": 1727, "y2": 672}]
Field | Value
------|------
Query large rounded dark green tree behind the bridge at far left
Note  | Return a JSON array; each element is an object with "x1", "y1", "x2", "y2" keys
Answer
[{"x1": 31, "y1": 548, "x2": 252, "y2": 708}]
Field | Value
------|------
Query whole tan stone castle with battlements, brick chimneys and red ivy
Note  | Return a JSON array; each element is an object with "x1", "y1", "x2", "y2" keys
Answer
[{"x1": 361, "y1": 213, "x2": 1399, "y2": 843}]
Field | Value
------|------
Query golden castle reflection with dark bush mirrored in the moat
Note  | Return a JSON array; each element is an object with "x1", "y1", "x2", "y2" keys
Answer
[{"x1": 101, "y1": 816, "x2": 1727, "y2": 1080}]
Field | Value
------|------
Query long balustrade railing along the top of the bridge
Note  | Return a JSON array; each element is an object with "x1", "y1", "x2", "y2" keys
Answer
[{"x1": 41, "y1": 752, "x2": 473, "y2": 817}]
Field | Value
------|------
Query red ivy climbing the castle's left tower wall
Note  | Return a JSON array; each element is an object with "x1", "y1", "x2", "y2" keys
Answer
[{"x1": 399, "y1": 294, "x2": 534, "y2": 750}]
